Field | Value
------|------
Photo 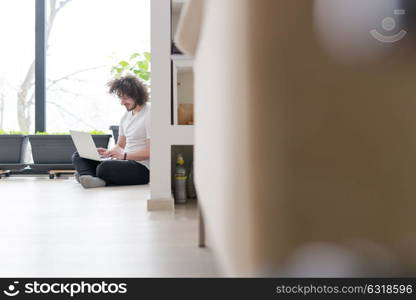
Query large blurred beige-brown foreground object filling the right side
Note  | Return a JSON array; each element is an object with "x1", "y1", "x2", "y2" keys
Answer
[{"x1": 177, "y1": 0, "x2": 416, "y2": 276}]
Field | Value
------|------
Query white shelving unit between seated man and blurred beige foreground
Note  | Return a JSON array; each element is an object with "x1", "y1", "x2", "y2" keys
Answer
[{"x1": 148, "y1": 0, "x2": 194, "y2": 210}]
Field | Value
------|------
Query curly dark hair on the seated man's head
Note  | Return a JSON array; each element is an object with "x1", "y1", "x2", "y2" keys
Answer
[{"x1": 107, "y1": 75, "x2": 149, "y2": 106}]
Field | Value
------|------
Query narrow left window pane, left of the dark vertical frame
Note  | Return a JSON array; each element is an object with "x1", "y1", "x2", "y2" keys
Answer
[{"x1": 0, "y1": 0, "x2": 35, "y2": 131}]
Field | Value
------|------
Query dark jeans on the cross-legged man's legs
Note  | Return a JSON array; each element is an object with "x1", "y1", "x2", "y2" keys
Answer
[{"x1": 72, "y1": 152, "x2": 149, "y2": 185}]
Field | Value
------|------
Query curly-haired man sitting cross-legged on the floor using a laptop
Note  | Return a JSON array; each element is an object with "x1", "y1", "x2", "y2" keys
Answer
[{"x1": 72, "y1": 75, "x2": 150, "y2": 188}]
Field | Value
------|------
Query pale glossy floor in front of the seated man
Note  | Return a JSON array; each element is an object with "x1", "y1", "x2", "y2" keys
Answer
[{"x1": 0, "y1": 177, "x2": 220, "y2": 277}]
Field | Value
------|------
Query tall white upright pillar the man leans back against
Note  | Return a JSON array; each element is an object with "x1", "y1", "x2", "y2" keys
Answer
[{"x1": 147, "y1": 0, "x2": 174, "y2": 210}]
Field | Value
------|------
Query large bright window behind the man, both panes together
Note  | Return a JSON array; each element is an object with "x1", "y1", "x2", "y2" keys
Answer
[{"x1": 0, "y1": 0, "x2": 150, "y2": 132}]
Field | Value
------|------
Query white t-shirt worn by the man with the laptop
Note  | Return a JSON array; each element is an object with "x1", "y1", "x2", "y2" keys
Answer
[{"x1": 118, "y1": 102, "x2": 150, "y2": 169}]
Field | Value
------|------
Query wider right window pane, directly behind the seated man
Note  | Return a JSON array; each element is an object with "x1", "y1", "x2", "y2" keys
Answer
[{"x1": 46, "y1": 0, "x2": 150, "y2": 131}]
